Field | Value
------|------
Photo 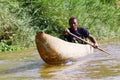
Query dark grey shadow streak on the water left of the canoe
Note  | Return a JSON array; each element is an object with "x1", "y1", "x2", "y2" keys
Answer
[{"x1": 0, "y1": 61, "x2": 41, "y2": 75}]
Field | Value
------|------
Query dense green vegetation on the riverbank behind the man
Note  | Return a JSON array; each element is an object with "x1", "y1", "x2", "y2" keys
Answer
[{"x1": 0, "y1": 0, "x2": 120, "y2": 51}]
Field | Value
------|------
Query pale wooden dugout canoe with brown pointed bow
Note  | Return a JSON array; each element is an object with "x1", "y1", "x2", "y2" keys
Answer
[{"x1": 35, "y1": 32, "x2": 93, "y2": 64}]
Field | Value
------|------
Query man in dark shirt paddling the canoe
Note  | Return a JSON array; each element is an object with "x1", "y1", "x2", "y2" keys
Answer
[{"x1": 64, "y1": 17, "x2": 98, "y2": 48}]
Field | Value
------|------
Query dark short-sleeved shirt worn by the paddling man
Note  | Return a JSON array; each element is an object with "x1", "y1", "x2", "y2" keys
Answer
[{"x1": 65, "y1": 27, "x2": 89, "y2": 44}]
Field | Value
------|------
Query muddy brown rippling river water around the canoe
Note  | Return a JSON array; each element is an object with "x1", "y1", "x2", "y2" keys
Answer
[{"x1": 0, "y1": 42, "x2": 120, "y2": 80}]
